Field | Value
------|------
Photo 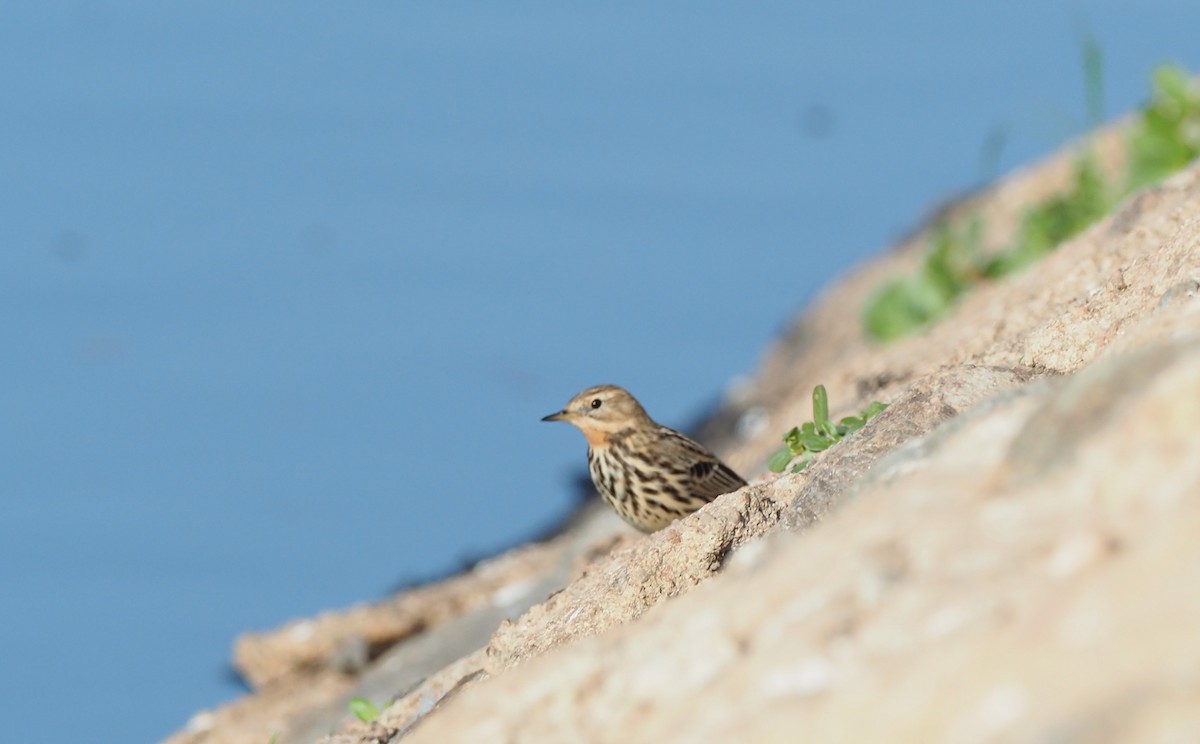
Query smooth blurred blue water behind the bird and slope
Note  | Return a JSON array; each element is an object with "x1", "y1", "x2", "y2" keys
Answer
[{"x1": 0, "y1": 0, "x2": 1200, "y2": 742}]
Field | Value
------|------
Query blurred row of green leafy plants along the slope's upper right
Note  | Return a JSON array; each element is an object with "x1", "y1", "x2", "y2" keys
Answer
[{"x1": 863, "y1": 48, "x2": 1200, "y2": 342}]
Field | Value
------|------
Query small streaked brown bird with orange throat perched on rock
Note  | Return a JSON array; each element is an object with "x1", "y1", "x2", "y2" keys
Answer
[{"x1": 542, "y1": 385, "x2": 746, "y2": 532}]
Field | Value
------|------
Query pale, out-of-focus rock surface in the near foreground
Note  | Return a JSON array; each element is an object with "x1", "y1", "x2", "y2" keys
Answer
[{"x1": 409, "y1": 338, "x2": 1200, "y2": 743}]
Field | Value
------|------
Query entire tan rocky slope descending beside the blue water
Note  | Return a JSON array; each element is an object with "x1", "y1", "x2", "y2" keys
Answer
[{"x1": 169, "y1": 120, "x2": 1200, "y2": 744}]
